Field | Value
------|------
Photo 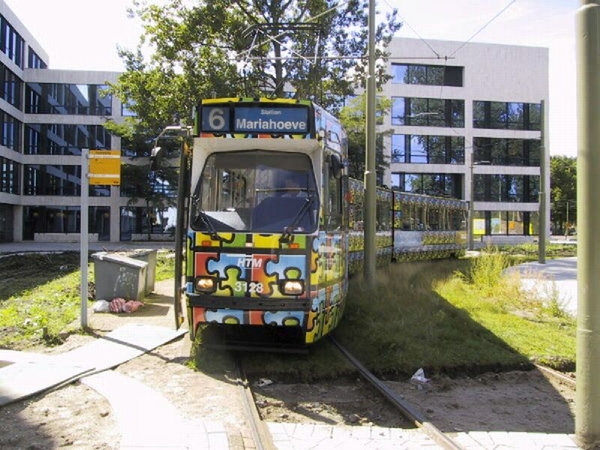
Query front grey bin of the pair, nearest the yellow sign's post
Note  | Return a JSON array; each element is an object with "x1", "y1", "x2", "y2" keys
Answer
[{"x1": 92, "y1": 252, "x2": 148, "y2": 301}]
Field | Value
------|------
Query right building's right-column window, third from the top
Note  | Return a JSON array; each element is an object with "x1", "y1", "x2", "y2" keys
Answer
[{"x1": 473, "y1": 174, "x2": 540, "y2": 203}]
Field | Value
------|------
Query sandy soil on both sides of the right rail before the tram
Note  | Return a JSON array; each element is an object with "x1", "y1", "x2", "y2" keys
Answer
[{"x1": 257, "y1": 370, "x2": 575, "y2": 433}]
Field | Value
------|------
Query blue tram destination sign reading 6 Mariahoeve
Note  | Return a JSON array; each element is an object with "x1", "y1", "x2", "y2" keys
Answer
[{"x1": 202, "y1": 103, "x2": 309, "y2": 134}]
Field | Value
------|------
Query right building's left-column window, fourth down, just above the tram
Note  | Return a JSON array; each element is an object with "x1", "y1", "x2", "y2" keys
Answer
[{"x1": 392, "y1": 173, "x2": 462, "y2": 198}]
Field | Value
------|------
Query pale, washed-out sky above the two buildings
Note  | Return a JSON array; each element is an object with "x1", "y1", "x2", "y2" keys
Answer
[{"x1": 4, "y1": 0, "x2": 580, "y2": 157}]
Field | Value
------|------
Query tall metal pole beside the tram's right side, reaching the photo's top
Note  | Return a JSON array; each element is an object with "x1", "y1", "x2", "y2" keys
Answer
[{"x1": 364, "y1": 0, "x2": 377, "y2": 283}]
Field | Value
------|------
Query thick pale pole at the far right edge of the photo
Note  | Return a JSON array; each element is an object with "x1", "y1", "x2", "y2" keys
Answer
[{"x1": 575, "y1": 0, "x2": 600, "y2": 448}]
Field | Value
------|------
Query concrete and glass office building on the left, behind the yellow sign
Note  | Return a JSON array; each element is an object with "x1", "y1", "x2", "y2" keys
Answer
[{"x1": 0, "y1": 0, "x2": 175, "y2": 242}]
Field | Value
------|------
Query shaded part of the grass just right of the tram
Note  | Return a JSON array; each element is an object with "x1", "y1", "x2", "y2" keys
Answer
[{"x1": 337, "y1": 261, "x2": 527, "y2": 376}]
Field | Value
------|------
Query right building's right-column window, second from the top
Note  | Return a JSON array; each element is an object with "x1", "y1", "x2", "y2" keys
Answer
[{"x1": 473, "y1": 137, "x2": 540, "y2": 167}]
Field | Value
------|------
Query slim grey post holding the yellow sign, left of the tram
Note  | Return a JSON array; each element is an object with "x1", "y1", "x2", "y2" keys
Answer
[{"x1": 79, "y1": 148, "x2": 90, "y2": 328}]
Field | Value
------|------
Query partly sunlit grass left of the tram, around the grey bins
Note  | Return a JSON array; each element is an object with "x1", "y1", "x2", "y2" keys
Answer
[{"x1": 0, "y1": 251, "x2": 174, "y2": 349}]
